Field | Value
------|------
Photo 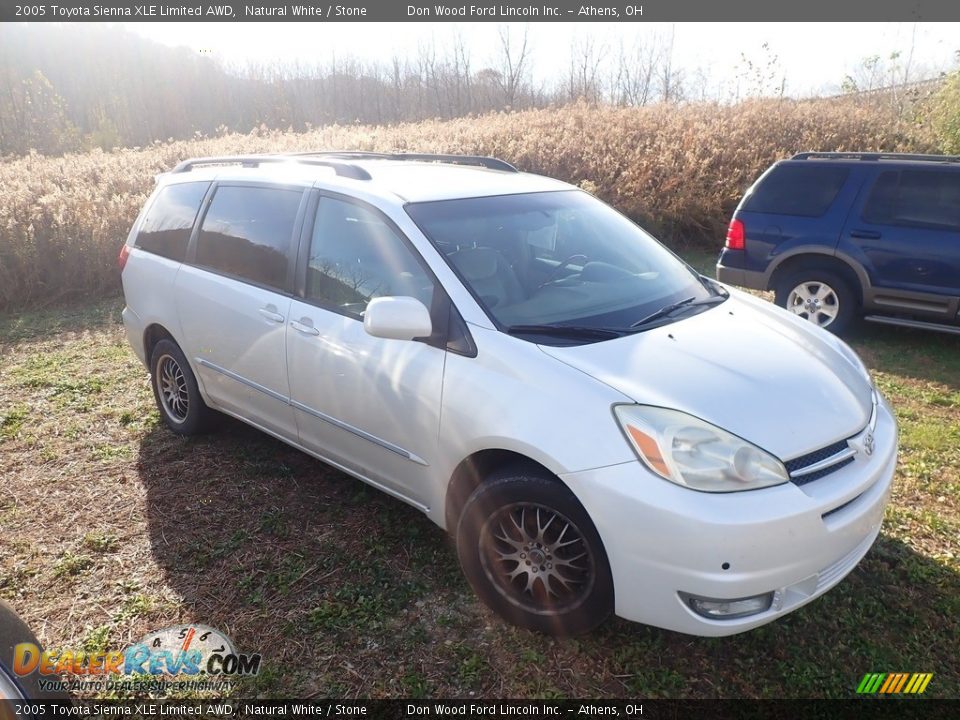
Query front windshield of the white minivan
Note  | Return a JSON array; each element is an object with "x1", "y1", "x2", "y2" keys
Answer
[{"x1": 406, "y1": 190, "x2": 726, "y2": 344}]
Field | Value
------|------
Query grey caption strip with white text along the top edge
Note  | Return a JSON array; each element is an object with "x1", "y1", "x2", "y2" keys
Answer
[{"x1": 0, "y1": 0, "x2": 960, "y2": 23}]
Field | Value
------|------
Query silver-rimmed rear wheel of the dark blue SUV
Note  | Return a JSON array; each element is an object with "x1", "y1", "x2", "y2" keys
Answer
[{"x1": 776, "y1": 268, "x2": 857, "y2": 335}]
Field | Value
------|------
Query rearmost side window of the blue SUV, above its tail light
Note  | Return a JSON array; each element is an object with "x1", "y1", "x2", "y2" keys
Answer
[{"x1": 743, "y1": 162, "x2": 850, "y2": 217}]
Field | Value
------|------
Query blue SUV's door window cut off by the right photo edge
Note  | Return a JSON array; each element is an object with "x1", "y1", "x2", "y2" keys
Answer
[{"x1": 863, "y1": 170, "x2": 960, "y2": 231}]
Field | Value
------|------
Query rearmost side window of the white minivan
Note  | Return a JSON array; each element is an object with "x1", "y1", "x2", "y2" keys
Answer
[{"x1": 136, "y1": 183, "x2": 210, "y2": 262}]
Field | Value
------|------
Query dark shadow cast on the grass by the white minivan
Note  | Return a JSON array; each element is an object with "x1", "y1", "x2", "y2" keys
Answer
[{"x1": 137, "y1": 420, "x2": 960, "y2": 697}]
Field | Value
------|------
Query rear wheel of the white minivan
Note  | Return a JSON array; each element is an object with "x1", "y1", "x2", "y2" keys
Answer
[{"x1": 150, "y1": 340, "x2": 213, "y2": 435}]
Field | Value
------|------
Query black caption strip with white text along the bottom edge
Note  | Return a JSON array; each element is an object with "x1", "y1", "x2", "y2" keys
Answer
[{"x1": 0, "y1": 697, "x2": 960, "y2": 720}]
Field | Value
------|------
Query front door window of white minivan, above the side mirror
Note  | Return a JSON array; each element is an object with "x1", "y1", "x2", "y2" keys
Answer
[{"x1": 306, "y1": 198, "x2": 434, "y2": 316}]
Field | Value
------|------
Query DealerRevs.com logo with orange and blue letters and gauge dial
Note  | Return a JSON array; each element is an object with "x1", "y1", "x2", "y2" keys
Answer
[{"x1": 13, "y1": 625, "x2": 261, "y2": 692}]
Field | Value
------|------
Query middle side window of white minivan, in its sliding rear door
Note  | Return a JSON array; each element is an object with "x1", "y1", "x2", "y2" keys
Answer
[{"x1": 197, "y1": 185, "x2": 303, "y2": 290}]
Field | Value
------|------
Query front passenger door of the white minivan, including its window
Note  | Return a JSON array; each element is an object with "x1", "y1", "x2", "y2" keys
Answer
[{"x1": 287, "y1": 197, "x2": 446, "y2": 506}]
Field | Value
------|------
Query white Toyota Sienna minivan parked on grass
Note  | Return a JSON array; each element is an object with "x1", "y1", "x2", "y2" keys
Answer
[{"x1": 120, "y1": 152, "x2": 897, "y2": 635}]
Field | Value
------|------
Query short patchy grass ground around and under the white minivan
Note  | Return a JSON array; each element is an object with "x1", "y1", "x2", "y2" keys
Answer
[{"x1": 0, "y1": 276, "x2": 960, "y2": 698}]
